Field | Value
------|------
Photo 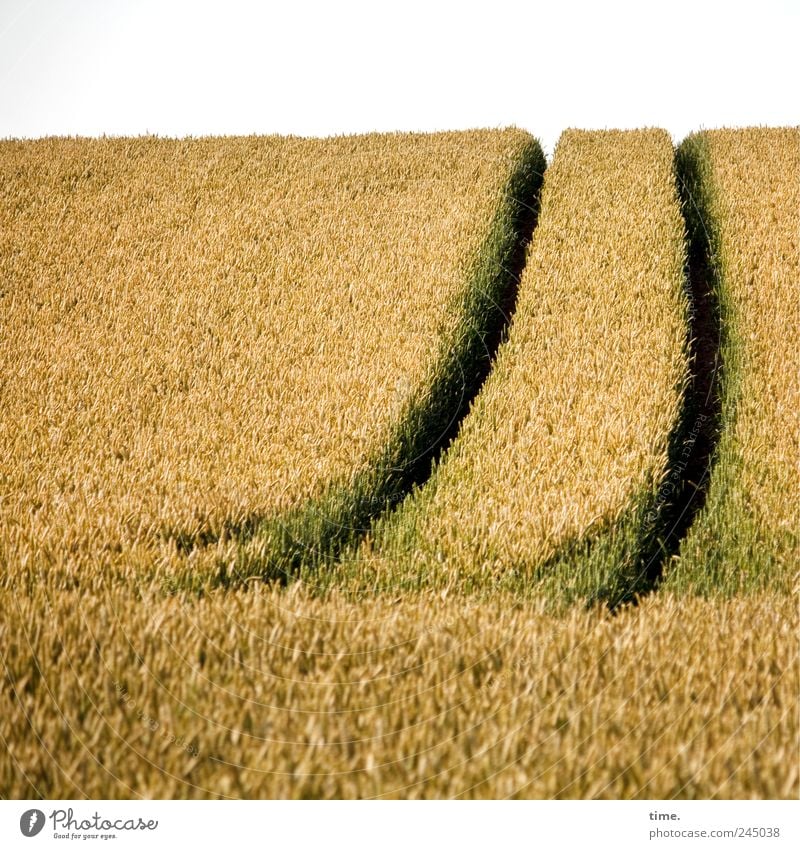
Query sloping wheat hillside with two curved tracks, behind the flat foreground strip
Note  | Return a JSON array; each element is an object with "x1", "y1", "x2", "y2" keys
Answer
[{"x1": 0, "y1": 129, "x2": 800, "y2": 603}]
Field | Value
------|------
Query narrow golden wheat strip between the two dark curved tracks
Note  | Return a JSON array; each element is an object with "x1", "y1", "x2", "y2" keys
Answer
[{"x1": 326, "y1": 130, "x2": 687, "y2": 601}]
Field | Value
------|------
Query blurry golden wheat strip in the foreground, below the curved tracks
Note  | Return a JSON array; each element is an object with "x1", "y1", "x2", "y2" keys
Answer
[{"x1": 0, "y1": 585, "x2": 800, "y2": 799}]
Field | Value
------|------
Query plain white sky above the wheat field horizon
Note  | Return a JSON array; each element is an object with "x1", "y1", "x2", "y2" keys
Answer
[{"x1": 0, "y1": 0, "x2": 800, "y2": 152}]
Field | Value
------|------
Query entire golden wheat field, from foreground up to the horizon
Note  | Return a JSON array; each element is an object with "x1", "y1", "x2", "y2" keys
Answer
[{"x1": 0, "y1": 129, "x2": 800, "y2": 799}]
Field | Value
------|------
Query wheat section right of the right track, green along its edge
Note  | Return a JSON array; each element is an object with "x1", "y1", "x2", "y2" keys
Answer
[{"x1": 668, "y1": 129, "x2": 800, "y2": 593}]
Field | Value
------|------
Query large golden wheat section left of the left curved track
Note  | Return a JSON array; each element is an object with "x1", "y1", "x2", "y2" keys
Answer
[{"x1": 0, "y1": 130, "x2": 544, "y2": 579}]
